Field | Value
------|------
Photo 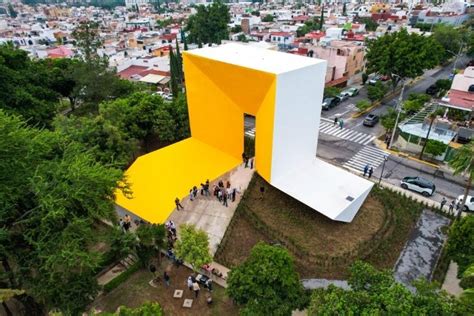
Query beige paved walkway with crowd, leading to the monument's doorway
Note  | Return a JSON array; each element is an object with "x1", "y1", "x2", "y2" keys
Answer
[{"x1": 168, "y1": 165, "x2": 255, "y2": 255}]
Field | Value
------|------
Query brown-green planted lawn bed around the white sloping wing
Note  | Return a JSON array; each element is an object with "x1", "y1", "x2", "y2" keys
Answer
[{"x1": 215, "y1": 175, "x2": 423, "y2": 279}]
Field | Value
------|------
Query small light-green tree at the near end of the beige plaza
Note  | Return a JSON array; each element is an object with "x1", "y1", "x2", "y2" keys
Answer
[{"x1": 175, "y1": 224, "x2": 212, "y2": 271}]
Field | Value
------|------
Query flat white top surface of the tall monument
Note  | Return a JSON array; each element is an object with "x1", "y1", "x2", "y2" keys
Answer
[{"x1": 186, "y1": 43, "x2": 325, "y2": 74}]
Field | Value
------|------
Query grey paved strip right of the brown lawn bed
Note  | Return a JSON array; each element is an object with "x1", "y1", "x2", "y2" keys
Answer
[{"x1": 394, "y1": 210, "x2": 450, "y2": 291}]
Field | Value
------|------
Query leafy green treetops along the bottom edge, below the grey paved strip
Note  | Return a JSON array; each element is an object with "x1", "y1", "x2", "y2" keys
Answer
[{"x1": 308, "y1": 262, "x2": 466, "y2": 315}]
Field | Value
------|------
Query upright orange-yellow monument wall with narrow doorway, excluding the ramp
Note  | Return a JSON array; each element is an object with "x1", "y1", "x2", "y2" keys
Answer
[{"x1": 183, "y1": 52, "x2": 276, "y2": 181}]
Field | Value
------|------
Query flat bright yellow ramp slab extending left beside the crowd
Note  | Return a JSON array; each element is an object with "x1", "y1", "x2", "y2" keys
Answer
[{"x1": 116, "y1": 138, "x2": 240, "y2": 223}]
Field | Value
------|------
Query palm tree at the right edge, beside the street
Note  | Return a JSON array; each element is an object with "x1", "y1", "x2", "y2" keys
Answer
[{"x1": 449, "y1": 141, "x2": 474, "y2": 216}]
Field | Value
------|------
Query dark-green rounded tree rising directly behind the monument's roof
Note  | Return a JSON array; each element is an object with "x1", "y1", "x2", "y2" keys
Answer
[{"x1": 186, "y1": 1, "x2": 230, "y2": 45}]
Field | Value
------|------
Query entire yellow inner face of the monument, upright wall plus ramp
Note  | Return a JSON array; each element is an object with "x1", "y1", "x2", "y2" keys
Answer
[{"x1": 116, "y1": 52, "x2": 276, "y2": 223}]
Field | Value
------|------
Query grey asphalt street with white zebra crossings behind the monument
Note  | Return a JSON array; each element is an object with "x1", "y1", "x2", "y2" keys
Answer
[{"x1": 245, "y1": 57, "x2": 472, "y2": 203}]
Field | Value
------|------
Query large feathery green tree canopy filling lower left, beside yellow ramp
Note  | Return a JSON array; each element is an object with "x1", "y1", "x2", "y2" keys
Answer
[{"x1": 0, "y1": 110, "x2": 122, "y2": 315}]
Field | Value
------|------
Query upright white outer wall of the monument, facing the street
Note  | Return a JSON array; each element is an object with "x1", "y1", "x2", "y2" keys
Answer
[{"x1": 271, "y1": 57, "x2": 327, "y2": 179}]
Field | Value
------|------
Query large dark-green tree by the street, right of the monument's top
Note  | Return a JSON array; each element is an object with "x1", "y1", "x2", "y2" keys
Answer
[{"x1": 366, "y1": 29, "x2": 444, "y2": 88}]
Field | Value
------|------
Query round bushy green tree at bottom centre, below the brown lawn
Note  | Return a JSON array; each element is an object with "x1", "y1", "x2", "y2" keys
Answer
[{"x1": 227, "y1": 243, "x2": 303, "y2": 315}]
